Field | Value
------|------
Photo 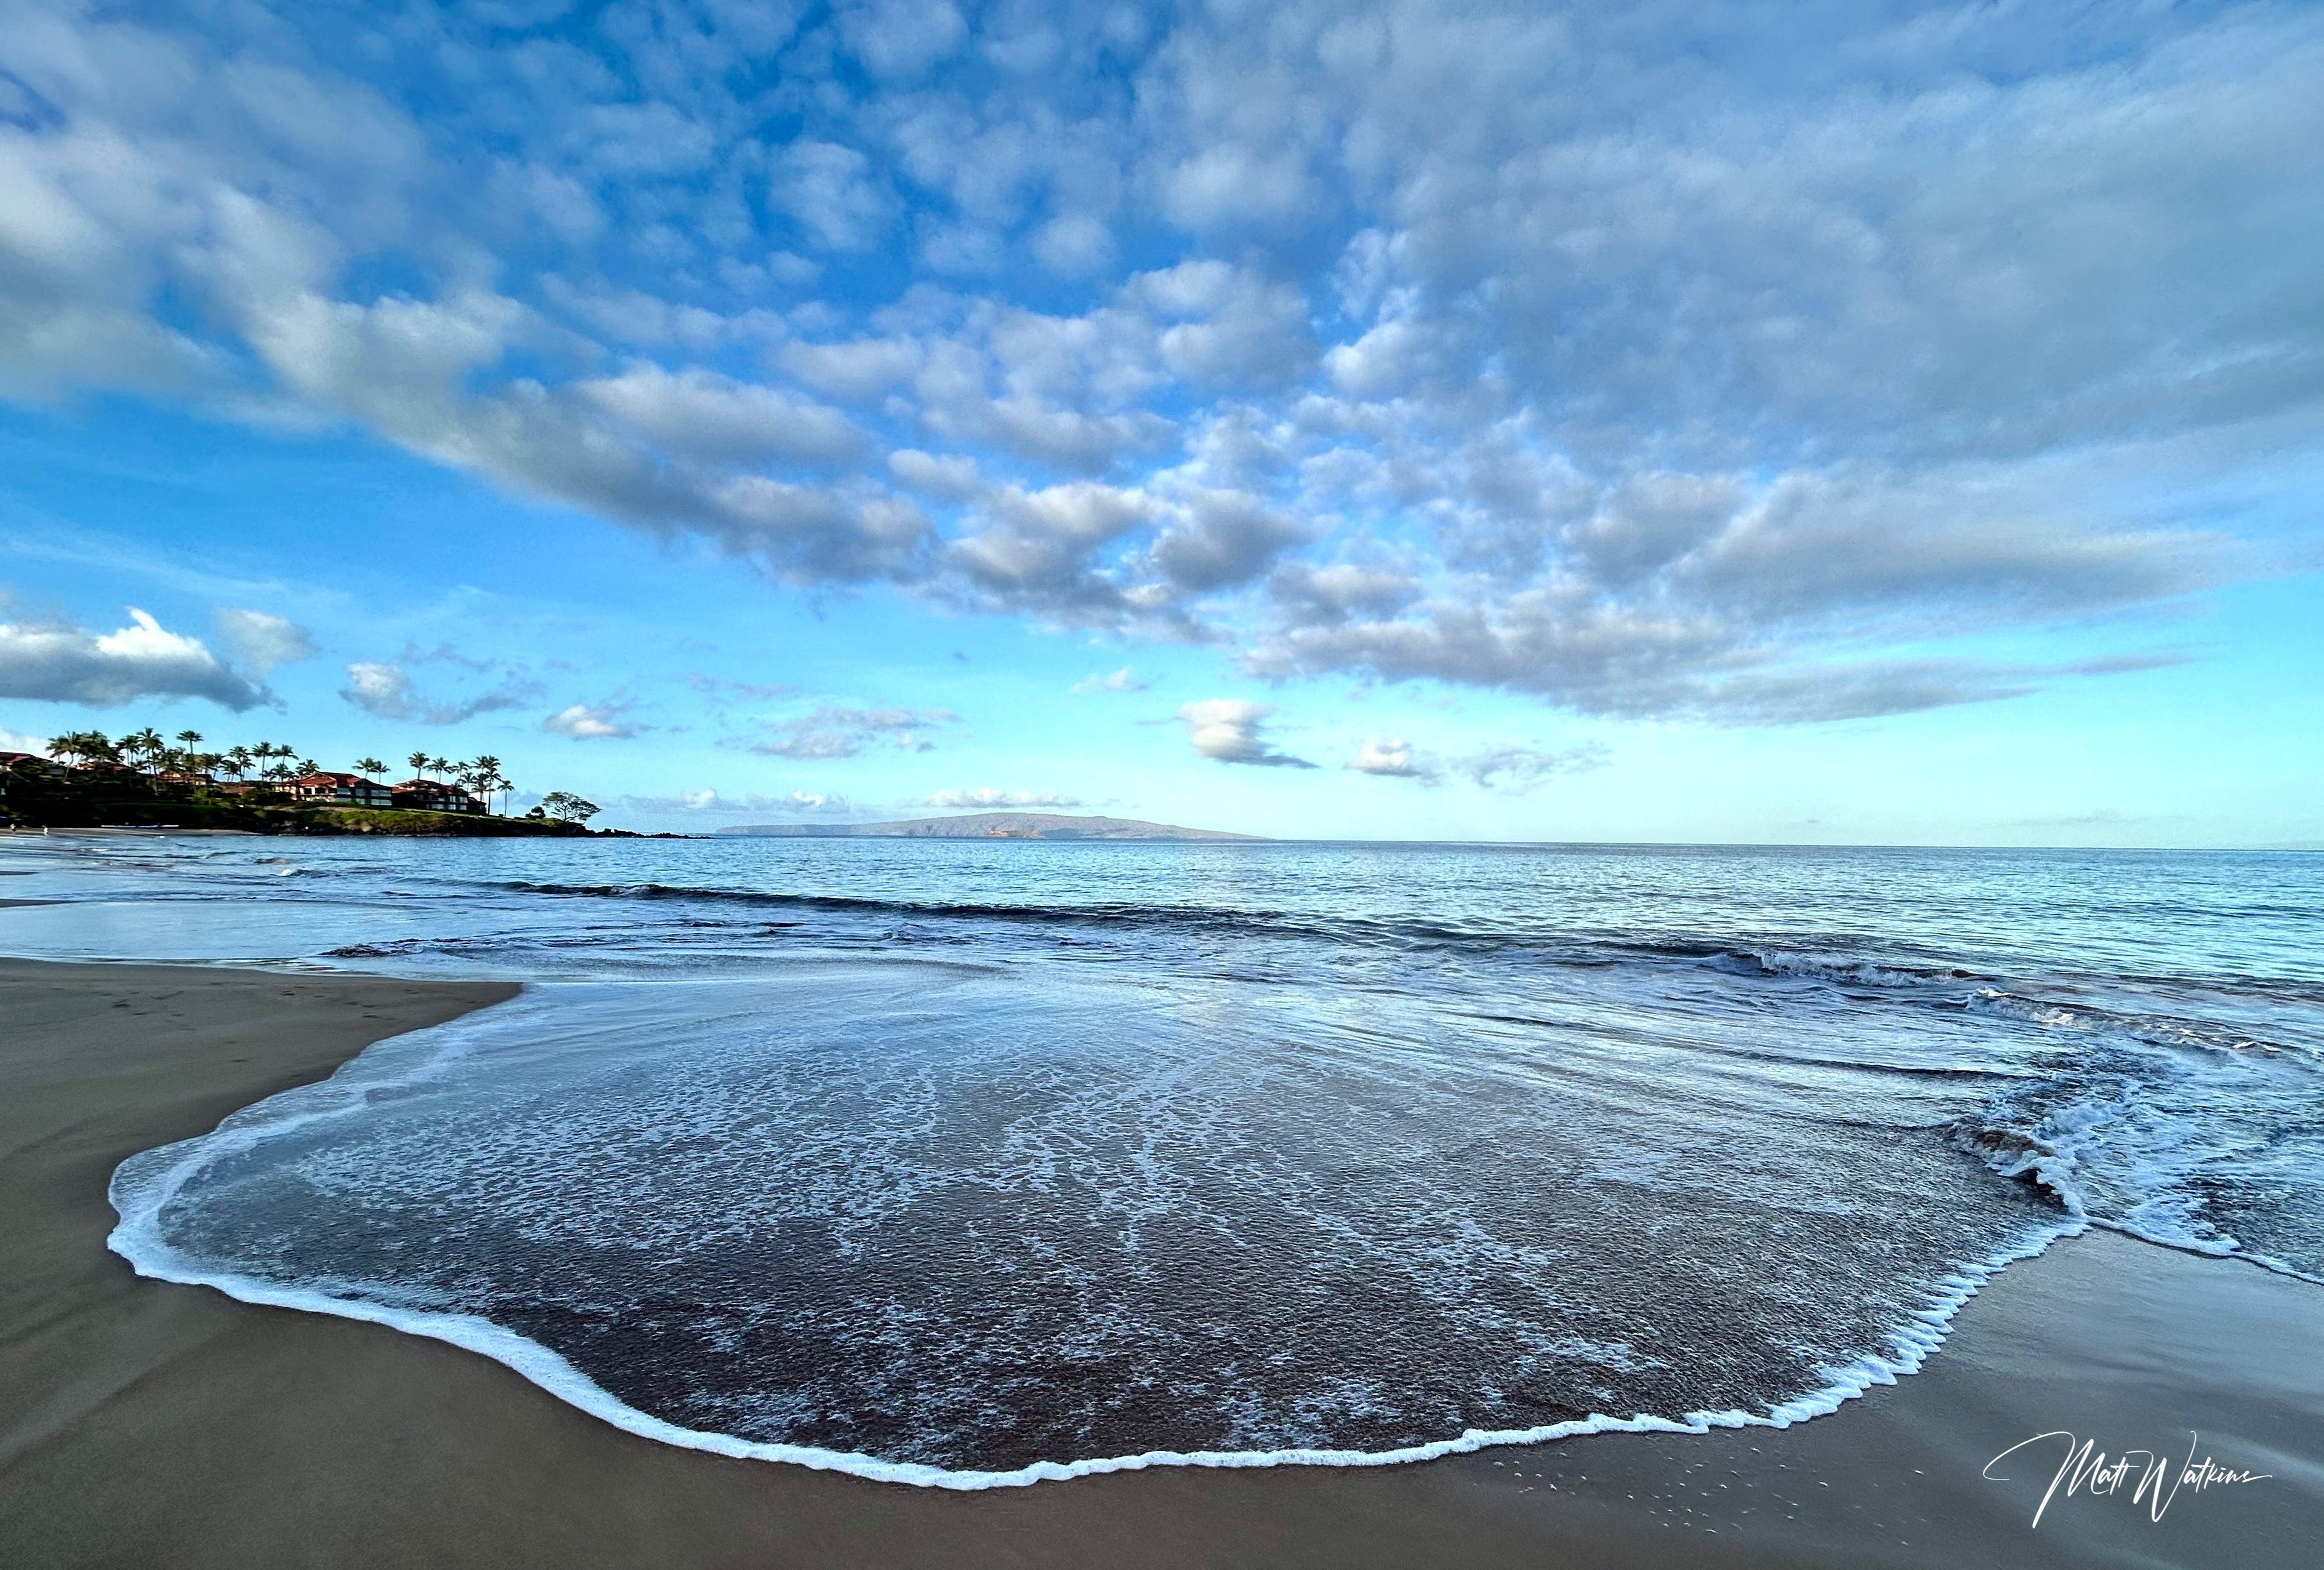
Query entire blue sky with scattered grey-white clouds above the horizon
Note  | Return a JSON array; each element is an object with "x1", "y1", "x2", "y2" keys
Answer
[{"x1": 0, "y1": 0, "x2": 2324, "y2": 846}]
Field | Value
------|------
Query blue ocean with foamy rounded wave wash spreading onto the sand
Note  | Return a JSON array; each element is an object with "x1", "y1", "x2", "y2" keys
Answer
[{"x1": 0, "y1": 836, "x2": 2324, "y2": 1489}]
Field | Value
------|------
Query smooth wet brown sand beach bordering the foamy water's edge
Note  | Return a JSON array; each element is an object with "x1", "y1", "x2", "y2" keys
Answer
[{"x1": 0, "y1": 961, "x2": 2324, "y2": 1570}]
